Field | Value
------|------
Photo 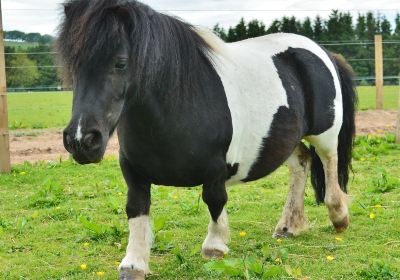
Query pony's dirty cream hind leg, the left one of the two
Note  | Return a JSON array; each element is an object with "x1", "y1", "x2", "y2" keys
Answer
[{"x1": 273, "y1": 143, "x2": 311, "y2": 238}]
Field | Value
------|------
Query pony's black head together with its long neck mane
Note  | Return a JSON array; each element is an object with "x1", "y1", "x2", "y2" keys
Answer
[{"x1": 57, "y1": 0, "x2": 211, "y2": 163}]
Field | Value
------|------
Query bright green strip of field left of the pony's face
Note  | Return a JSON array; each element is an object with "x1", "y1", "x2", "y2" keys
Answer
[{"x1": 8, "y1": 92, "x2": 72, "y2": 129}]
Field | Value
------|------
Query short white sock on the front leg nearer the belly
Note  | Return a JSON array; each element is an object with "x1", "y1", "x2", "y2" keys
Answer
[{"x1": 202, "y1": 209, "x2": 229, "y2": 254}]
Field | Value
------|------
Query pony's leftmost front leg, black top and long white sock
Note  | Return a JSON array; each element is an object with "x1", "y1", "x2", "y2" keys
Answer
[{"x1": 119, "y1": 156, "x2": 153, "y2": 280}]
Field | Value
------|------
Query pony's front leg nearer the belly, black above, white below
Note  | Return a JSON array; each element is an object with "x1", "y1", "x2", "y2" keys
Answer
[{"x1": 202, "y1": 174, "x2": 229, "y2": 258}]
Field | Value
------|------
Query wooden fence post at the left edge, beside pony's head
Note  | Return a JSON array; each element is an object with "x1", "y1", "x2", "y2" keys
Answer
[{"x1": 0, "y1": 0, "x2": 11, "y2": 173}]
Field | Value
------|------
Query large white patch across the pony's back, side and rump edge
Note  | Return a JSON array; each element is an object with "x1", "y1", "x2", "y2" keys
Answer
[{"x1": 198, "y1": 31, "x2": 343, "y2": 184}]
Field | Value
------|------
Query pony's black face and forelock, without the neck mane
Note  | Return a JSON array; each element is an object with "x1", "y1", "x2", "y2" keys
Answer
[{"x1": 57, "y1": 0, "x2": 142, "y2": 164}]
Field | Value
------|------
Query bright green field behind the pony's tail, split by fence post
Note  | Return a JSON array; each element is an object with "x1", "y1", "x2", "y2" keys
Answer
[{"x1": 357, "y1": 86, "x2": 400, "y2": 111}]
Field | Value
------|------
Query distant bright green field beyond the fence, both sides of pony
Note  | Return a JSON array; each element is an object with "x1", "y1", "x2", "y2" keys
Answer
[{"x1": 8, "y1": 86, "x2": 400, "y2": 129}]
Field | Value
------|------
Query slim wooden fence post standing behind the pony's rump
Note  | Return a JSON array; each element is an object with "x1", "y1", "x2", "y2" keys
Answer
[{"x1": 375, "y1": 35, "x2": 383, "y2": 110}]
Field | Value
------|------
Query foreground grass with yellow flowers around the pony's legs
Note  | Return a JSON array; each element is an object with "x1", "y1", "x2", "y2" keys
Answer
[{"x1": 0, "y1": 135, "x2": 400, "y2": 280}]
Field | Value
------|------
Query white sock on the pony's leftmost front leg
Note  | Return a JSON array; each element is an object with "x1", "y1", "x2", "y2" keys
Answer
[{"x1": 119, "y1": 216, "x2": 153, "y2": 273}]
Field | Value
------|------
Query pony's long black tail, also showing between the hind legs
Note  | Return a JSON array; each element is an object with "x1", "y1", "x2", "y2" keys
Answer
[{"x1": 310, "y1": 54, "x2": 358, "y2": 203}]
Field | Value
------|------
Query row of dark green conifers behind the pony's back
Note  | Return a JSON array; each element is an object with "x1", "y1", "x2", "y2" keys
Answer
[{"x1": 214, "y1": 11, "x2": 400, "y2": 85}]
